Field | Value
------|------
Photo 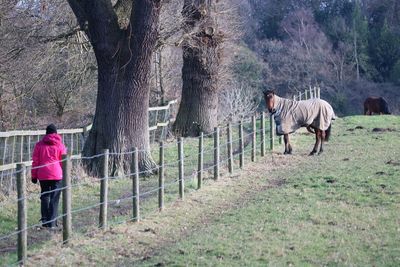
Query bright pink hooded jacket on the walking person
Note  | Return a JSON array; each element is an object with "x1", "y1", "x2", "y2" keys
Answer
[{"x1": 31, "y1": 133, "x2": 67, "y2": 181}]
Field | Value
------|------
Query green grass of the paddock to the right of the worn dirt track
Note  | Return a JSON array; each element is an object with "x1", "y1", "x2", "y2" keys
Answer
[{"x1": 137, "y1": 116, "x2": 400, "y2": 266}]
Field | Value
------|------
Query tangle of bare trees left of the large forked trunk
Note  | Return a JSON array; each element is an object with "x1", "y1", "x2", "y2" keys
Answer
[{"x1": 0, "y1": 0, "x2": 97, "y2": 130}]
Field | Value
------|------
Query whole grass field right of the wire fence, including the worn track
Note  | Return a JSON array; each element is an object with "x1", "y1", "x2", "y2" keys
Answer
[{"x1": 0, "y1": 116, "x2": 400, "y2": 266}]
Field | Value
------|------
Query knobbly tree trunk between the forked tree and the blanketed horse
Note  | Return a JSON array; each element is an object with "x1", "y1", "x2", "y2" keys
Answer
[{"x1": 174, "y1": 0, "x2": 222, "y2": 136}]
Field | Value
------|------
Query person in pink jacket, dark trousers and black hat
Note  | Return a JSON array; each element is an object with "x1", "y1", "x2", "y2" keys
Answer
[{"x1": 31, "y1": 124, "x2": 67, "y2": 228}]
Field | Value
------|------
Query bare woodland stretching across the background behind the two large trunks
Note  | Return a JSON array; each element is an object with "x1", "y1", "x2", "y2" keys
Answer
[{"x1": 0, "y1": 0, "x2": 400, "y2": 131}]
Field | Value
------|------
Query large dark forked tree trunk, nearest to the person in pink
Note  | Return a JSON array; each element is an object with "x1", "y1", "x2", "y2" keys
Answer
[{"x1": 69, "y1": 0, "x2": 160, "y2": 174}]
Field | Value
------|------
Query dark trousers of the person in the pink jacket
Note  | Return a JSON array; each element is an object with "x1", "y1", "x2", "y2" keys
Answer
[{"x1": 40, "y1": 180, "x2": 62, "y2": 227}]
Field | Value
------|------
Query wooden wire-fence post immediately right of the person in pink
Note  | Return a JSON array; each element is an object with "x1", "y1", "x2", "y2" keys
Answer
[{"x1": 62, "y1": 154, "x2": 72, "y2": 244}]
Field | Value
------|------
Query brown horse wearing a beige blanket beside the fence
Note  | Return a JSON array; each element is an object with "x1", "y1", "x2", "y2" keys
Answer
[{"x1": 264, "y1": 90, "x2": 335, "y2": 155}]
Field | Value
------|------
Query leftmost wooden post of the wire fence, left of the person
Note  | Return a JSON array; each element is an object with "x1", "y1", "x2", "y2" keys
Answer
[{"x1": 17, "y1": 164, "x2": 28, "y2": 264}]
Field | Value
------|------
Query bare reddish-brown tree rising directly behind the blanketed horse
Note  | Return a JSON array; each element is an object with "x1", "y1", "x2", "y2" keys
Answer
[{"x1": 258, "y1": 9, "x2": 351, "y2": 94}]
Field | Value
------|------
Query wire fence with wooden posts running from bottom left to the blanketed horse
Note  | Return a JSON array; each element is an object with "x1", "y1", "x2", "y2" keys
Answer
[{"x1": 0, "y1": 88, "x2": 322, "y2": 264}]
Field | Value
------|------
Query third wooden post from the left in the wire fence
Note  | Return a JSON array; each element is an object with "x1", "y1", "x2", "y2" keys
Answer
[{"x1": 99, "y1": 149, "x2": 109, "y2": 229}]
